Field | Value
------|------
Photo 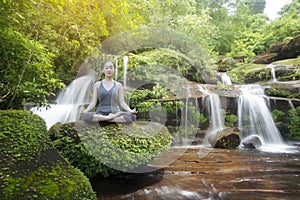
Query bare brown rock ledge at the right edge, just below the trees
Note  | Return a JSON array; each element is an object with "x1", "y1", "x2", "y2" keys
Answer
[{"x1": 254, "y1": 35, "x2": 300, "y2": 64}]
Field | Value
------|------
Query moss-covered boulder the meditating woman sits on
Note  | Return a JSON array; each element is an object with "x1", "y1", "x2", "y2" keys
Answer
[{"x1": 49, "y1": 121, "x2": 171, "y2": 178}]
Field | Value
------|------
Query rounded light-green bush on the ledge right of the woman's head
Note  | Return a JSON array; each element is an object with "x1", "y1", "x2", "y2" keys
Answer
[{"x1": 128, "y1": 49, "x2": 203, "y2": 84}]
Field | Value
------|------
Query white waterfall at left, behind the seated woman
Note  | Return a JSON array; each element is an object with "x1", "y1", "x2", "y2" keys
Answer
[{"x1": 31, "y1": 73, "x2": 95, "y2": 129}]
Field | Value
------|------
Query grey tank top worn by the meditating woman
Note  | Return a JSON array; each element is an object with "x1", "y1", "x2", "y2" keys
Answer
[{"x1": 96, "y1": 81, "x2": 120, "y2": 115}]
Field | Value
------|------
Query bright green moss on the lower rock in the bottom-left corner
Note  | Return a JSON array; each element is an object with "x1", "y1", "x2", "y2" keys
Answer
[{"x1": 2, "y1": 164, "x2": 95, "y2": 200}]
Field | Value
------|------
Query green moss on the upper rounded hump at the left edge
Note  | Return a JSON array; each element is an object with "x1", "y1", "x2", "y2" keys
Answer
[{"x1": 0, "y1": 110, "x2": 49, "y2": 170}]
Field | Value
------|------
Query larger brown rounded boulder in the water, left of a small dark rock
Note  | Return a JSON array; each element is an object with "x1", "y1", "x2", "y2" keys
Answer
[{"x1": 208, "y1": 128, "x2": 241, "y2": 149}]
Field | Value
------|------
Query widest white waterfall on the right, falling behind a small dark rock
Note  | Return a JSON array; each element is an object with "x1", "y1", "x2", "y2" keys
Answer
[{"x1": 238, "y1": 85, "x2": 283, "y2": 144}]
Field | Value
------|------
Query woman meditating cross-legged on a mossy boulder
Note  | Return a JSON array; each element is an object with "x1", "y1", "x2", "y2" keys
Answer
[{"x1": 83, "y1": 61, "x2": 136, "y2": 122}]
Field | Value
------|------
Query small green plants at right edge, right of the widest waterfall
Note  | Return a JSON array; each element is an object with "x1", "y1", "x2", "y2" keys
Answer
[{"x1": 288, "y1": 106, "x2": 300, "y2": 140}]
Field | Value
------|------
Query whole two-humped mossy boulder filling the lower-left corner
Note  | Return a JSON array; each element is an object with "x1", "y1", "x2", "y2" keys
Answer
[{"x1": 0, "y1": 110, "x2": 96, "y2": 200}]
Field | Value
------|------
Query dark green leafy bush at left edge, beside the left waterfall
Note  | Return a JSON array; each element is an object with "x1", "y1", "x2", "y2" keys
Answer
[{"x1": 0, "y1": 29, "x2": 63, "y2": 109}]
